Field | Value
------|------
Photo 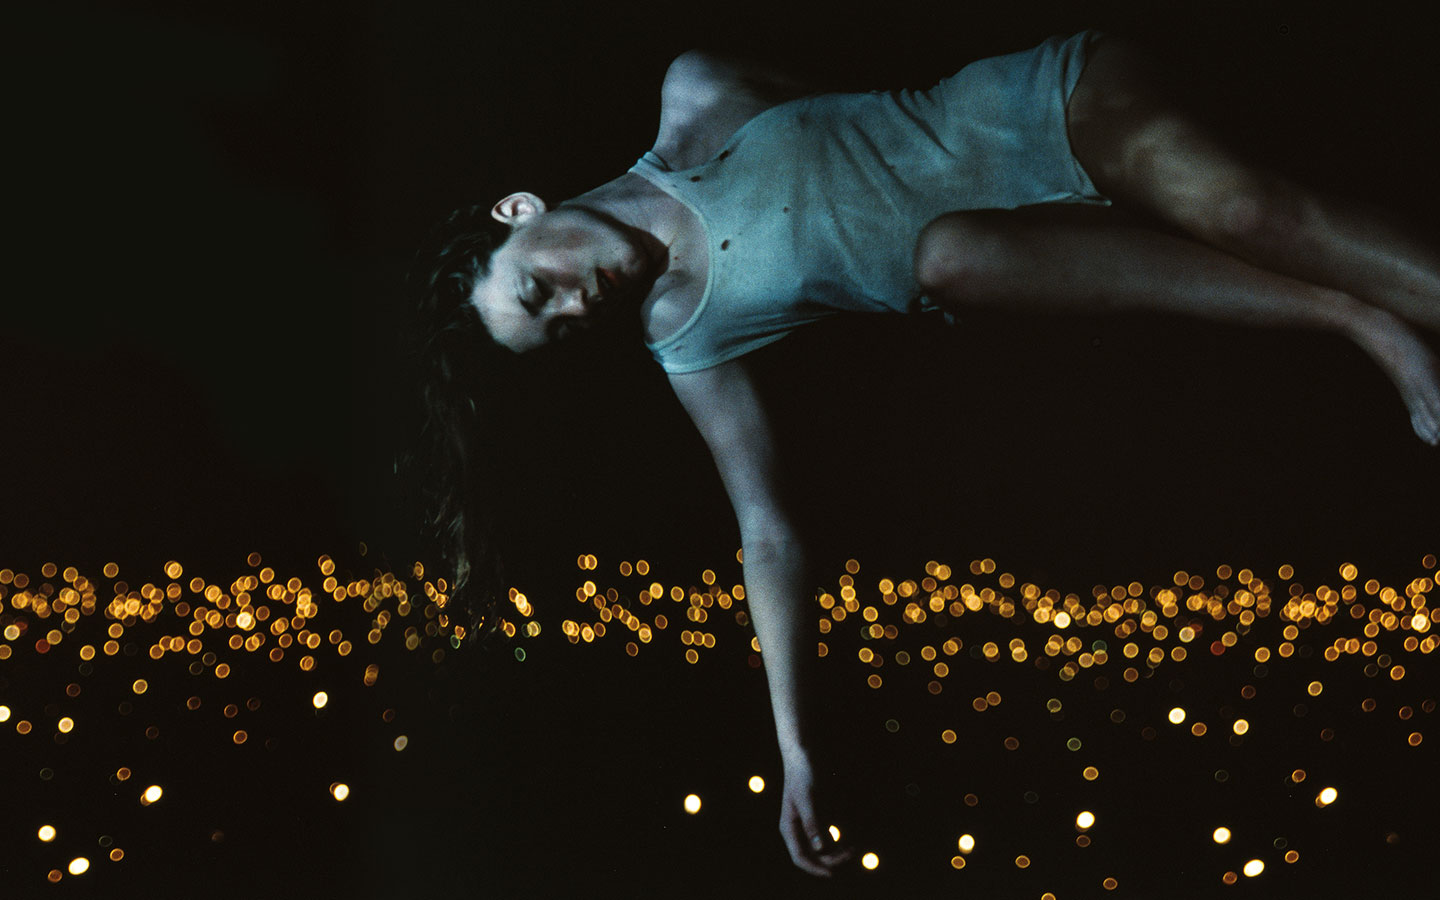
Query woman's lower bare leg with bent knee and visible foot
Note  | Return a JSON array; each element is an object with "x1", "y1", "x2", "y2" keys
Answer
[{"x1": 916, "y1": 207, "x2": 1440, "y2": 444}]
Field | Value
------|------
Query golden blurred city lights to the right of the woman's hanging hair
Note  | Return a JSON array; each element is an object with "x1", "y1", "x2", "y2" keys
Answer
[{"x1": 562, "y1": 554, "x2": 1440, "y2": 896}]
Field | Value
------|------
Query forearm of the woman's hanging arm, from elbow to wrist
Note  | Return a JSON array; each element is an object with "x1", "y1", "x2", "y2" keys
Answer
[{"x1": 742, "y1": 526, "x2": 818, "y2": 762}]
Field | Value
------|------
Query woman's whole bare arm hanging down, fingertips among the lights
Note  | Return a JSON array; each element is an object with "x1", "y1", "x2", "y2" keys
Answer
[{"x1": 670, "y1": 360, "x2": 850, "y2": 876}]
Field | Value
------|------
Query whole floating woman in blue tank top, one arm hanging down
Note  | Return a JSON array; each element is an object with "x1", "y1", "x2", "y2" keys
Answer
[{"x1": 408, "y1": 32, "x2": 1440, "y2": 876}]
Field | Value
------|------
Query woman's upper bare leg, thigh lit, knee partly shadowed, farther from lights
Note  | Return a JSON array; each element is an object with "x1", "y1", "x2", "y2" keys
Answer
[{"x1": 1067, "y1": 40, "x2": 1440, "y2": 330}]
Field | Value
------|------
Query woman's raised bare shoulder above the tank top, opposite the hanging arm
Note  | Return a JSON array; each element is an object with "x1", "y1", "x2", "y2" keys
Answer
[{"x1": 654, "y1": 50, "x2": 814, "y2": 170}]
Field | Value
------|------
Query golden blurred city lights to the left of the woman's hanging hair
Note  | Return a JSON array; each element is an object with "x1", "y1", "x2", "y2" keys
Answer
[{"x1": 0, "y1": 547, "x2": 478, "y2": 883}]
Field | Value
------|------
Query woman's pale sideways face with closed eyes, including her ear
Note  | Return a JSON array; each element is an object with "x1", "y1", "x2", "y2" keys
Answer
[{"x1": 471, "y1": 194, "x2": 647, "y2": 353}]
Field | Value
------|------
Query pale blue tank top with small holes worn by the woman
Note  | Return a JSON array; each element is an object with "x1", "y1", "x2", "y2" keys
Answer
[{"x1": 631, "y1": 32, "x2": 1109, "y2": 373}]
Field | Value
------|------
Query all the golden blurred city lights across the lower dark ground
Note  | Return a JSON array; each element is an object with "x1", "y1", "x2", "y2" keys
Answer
[{"x1": 0, "y1": 544, "x2": 1440, "y2": 896}]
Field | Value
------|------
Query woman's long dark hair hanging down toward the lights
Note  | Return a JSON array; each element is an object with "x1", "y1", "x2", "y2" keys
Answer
[{"x1": 397, "y1": 206, "x2": 513, "y2": 638}]
